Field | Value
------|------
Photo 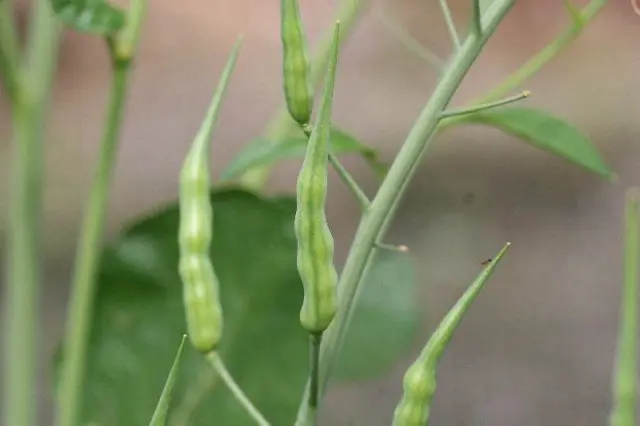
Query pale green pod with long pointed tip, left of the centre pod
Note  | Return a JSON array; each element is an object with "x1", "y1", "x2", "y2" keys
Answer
[{"x1": 178, "y1": 40, "x2": 241, "y2": 353}]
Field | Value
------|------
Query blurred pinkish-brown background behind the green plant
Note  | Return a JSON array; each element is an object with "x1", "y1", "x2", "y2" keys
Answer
[{"x1": 0, "y1": 0, "x2": 640, "y2": 426}]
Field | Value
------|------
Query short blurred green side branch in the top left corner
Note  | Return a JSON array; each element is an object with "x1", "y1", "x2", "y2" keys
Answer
[{"x1": 0, "y1": 0, "x2": 20, "y2": 105}]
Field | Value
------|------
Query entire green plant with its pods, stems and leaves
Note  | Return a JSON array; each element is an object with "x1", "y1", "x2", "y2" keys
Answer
[{"x1": 0, "y1": 0, "x2": 638, "y2": 426}]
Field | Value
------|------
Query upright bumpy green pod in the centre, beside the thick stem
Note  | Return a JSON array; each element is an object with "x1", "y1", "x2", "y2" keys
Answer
[{"x1": 294, "y1": 23, "x2": 339, "y2": 334}]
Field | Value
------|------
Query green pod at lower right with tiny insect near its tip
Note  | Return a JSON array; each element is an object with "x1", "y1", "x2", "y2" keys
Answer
[{"x1": 393, "y1": 243, "x2": 511, "y2": 426}]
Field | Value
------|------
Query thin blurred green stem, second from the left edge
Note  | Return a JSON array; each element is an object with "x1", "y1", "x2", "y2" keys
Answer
[{"x1": 58, "y1": 53, "x2": 131, "y2": 426}]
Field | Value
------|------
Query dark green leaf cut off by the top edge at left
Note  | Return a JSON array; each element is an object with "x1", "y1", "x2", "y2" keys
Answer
[{"x1": 50, "y1": 0, "x2": 125, "y2": 36}]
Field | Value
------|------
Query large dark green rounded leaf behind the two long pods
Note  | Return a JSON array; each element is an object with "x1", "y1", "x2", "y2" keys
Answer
[{"x1": 58, "y1": 188, "x2": 416, "y2": 426}]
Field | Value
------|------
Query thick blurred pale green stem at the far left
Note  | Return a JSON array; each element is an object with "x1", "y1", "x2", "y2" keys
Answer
[{"x1": 0, "y1": 0, "x2": 58, "y2": 426}]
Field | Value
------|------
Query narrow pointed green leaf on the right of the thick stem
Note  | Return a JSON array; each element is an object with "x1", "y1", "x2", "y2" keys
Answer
[{"x1": 461, "y1": 107, "x2": 613, "y2": 179}]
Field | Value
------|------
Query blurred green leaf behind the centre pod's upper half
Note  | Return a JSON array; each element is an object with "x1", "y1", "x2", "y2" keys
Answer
[{"x1": 221, "y1": 128, "x2": 387, "y2": 180}]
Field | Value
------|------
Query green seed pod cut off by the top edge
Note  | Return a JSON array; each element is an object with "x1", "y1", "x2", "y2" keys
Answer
[{"x1": 280, "y1": 0, "x2": 313, "y2": 127}]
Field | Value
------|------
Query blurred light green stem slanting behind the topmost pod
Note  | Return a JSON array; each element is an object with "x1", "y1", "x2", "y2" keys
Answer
[{"x1": 240, "y1": 0, "x2": 369, "y2": 189}]
